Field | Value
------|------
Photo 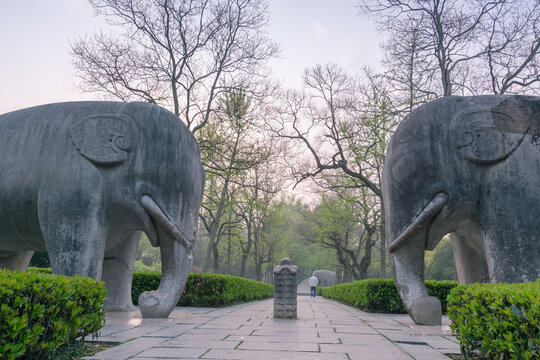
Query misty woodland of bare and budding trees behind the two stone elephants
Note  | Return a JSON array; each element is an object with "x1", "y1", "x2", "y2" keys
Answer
[{"x1": 13, "y1": 0, "x2": 540, "y2": 282}]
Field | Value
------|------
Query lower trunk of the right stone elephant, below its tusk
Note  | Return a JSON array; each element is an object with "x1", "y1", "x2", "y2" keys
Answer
[{"x1": 390, "y1": 231, "x2": 442, "y2": 325}]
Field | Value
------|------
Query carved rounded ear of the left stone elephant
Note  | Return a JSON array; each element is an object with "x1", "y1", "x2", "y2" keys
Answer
[{"x1": 70, "y1": 114, "x2": 135, "y2": 166}]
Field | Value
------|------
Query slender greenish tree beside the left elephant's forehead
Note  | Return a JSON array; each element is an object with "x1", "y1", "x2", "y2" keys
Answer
[{"x1": 198, "y1": 90, "x2": 268, "y2": 272}]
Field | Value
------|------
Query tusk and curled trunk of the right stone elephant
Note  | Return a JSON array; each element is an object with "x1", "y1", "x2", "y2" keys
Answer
[{"x1": 388, "y1": 193, "x2": 448, "y2": 325}]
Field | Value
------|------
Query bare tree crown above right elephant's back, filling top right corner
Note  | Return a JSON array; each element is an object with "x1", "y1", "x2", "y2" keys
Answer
[{"x1": 359, "y1": 0, "x2": 540, "y2": 96}]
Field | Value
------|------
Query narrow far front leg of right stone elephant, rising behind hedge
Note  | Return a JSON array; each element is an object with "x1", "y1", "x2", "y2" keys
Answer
[{"x1": 450, "y1": 228, "x2": 489, "y2": 284}]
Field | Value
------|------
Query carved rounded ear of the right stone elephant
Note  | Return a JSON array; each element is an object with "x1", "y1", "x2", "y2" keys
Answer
[{"x1": 449, "y1": 107, "x2": 528, "y2": 164}]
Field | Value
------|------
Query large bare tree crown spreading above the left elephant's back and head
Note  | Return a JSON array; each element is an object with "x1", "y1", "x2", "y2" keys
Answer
[{"x1": 72, "y1": 0, "x2": 279, "y2": 132}]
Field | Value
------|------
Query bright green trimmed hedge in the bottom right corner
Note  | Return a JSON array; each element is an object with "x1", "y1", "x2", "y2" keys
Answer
[{"x1": 448, "y1": 279, "x2": 540, "y2": 360}]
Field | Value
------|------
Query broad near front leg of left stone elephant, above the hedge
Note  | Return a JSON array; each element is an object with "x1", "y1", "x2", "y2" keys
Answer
[{"x1": 38, "y1": 184, "x2": 106, "y2": 280}]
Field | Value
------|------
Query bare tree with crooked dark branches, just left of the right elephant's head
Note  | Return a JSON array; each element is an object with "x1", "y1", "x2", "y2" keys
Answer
[{"x1": 269, "y1": 64, "x2": 396, "y2": 276}]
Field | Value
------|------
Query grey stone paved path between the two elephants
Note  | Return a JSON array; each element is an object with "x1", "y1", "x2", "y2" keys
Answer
[{"x1": 85, "y1": 296, "x2": 459, "y2": 360}]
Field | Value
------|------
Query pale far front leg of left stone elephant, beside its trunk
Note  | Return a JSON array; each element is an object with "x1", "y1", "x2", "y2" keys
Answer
[{"x1": 102, "y1": 231, "x2": 141, "y2": 311}]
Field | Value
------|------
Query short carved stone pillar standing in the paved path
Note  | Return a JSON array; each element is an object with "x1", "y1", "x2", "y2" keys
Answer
[{"x1": 274, "y1": 258, "x2": 297, "y2": 319}]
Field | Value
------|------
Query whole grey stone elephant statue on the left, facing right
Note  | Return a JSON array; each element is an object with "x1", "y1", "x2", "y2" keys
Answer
[{"x1": 0, "y1": 102, "x2": 204, "y2": 317}]
